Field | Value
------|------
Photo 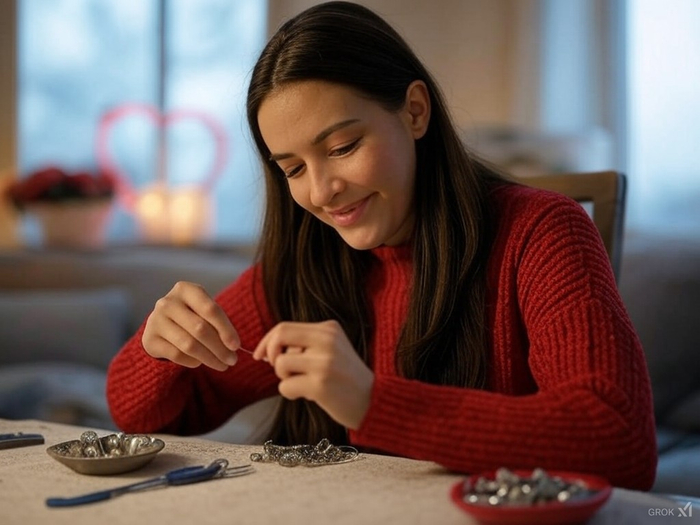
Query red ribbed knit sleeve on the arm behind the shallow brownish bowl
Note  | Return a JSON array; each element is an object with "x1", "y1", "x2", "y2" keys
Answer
[{"x1": 107, "y1": 268, "x2": 278, "y2": 435}]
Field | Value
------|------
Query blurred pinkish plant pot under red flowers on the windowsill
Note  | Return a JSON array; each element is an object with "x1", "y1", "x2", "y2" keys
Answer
[{"x1": 26, "y1": 199, "x2": 112, "y2": 249}]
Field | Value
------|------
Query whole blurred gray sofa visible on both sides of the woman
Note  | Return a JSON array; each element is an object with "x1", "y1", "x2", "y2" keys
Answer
[{"x1": 0, "y1": 237, "x2": 700, "y2": 497}]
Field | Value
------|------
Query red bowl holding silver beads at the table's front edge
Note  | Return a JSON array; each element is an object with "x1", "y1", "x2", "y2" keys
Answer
[{"x1": 450, "y1": 470, "x2": 612, "y2": 525}]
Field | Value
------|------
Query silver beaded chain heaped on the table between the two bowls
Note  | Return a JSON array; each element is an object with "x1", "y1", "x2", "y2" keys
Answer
[{"x1": 250, "y1": 438, "x2": 360, "y2": 467}]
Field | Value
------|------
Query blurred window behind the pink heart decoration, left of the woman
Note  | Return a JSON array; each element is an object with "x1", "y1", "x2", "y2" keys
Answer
[{"x1": 18, "y1": 0, "x2": 267, "y2": 242}]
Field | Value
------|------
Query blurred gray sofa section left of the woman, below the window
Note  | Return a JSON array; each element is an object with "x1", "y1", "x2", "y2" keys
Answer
[{"x1": 0, "y1": 247, "x2": 252, "y2": 429}]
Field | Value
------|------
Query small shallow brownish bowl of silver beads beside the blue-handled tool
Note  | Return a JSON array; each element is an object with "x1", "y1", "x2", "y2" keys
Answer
[{"x1": 46, "y1": 431, "x2": 165, "y2": 476}]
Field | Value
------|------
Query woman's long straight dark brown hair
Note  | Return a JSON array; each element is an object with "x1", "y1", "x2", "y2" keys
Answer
[{"x1": 247, "y1": 2, "x2": 500, "y2": 443}]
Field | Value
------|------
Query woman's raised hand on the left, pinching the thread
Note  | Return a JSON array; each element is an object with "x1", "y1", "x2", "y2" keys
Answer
[{"x1": 141, "y1": 281, "x2": 241, "y2": 372}]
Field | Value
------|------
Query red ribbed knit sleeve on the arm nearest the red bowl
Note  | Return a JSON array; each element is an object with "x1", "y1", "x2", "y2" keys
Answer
[{"x1": 350, "y1": 187, "x2": 656, "y2": 489}]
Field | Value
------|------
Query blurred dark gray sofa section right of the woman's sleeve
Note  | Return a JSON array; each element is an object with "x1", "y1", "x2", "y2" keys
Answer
[{"x1": 619, "y1": 232, "x2": 700, "y2": 497}]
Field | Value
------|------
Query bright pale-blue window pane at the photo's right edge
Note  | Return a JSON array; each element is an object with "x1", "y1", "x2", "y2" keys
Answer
[{"x1": 627, "y1": 0, "x2": 700, "y2": 235}]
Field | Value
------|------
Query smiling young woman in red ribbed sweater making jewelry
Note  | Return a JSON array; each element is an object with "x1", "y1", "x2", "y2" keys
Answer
[{"x1": 108, "y1": 2, "x2": 656, "y2": 489}]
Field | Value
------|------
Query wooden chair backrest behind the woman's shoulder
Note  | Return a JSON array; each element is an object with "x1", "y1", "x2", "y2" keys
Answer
[{"x1": 520, "y1": 171, "x2": 627, "y2": 280}]
